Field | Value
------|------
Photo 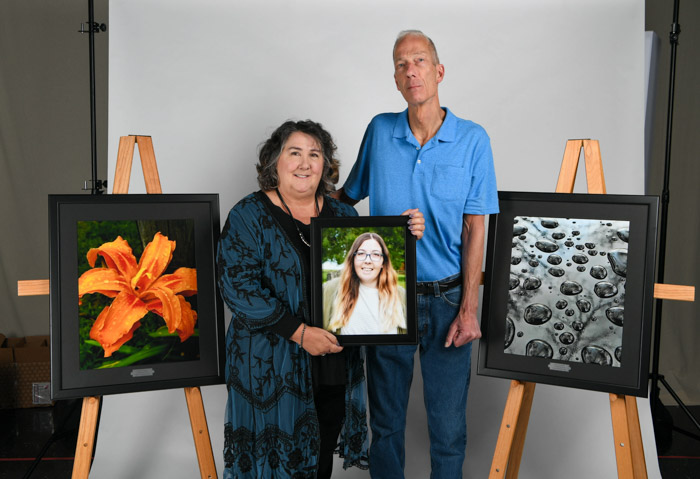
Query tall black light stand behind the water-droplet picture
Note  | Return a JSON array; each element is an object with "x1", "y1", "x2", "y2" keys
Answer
[{"x1": 650, "y1": 0, "x2": 700, "y2": 450}]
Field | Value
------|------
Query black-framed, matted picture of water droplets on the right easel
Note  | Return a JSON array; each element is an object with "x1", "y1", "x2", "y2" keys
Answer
[{"x1": 477, "y1": 191, "x2": 658, "y2": 396}]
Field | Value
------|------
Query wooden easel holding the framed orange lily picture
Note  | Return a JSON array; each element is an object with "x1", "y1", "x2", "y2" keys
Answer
[{"x1": 17, "y1": 135, "x2": 217, "y2": 479}]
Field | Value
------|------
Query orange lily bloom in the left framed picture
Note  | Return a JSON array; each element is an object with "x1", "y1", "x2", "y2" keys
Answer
[{"x1": 78, "y1": 233, "x2": 197, "y2": 357}]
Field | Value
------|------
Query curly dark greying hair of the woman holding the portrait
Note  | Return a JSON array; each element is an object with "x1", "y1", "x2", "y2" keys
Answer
[{"x1": 255, "y1": 120, "x2": 340, "y2": 196}]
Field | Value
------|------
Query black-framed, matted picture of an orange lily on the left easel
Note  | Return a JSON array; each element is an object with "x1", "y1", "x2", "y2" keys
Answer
[{"x1": 49, "y1": 194, "x2": 223, "y2": 399}]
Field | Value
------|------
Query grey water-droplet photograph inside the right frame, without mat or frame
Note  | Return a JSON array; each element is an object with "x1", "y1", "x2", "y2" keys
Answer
[{"x1": 505, "y1": 216, "x2": 629, "y2": 367}]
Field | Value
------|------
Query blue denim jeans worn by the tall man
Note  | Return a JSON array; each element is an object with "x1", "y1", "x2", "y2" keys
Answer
[{"x1": 367, "y1": 280, "x2": 472, "y2": 479}]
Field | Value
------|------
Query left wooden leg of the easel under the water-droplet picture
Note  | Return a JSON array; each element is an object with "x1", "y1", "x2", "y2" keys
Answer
[{"x1": 489, "y1": 381, "x2": 535, "y2": 479}]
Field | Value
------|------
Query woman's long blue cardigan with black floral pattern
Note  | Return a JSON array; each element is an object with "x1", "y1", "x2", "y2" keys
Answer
[{"x1": 217, "y1": 192, "x2": 367, "y2": 478}]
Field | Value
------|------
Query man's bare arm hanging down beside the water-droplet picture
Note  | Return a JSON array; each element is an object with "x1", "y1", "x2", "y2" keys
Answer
[{"x1": 445, "y1": 215, "x2": 486, "y2": 348}]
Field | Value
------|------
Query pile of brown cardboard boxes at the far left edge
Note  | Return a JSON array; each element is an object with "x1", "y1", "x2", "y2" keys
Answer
[{"x1": 0, "y1": 334, "x2": 52, "y2": 409}]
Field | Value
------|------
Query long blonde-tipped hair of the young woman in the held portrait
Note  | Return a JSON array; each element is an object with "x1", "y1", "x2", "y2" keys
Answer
[{"x1": 329, "y1": 232, "x2": 406, "y2": 331}]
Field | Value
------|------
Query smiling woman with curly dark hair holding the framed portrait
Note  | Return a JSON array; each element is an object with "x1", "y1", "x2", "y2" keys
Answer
[{"x1": 218, "y1": 121, "x2": 424, "y2": 478}]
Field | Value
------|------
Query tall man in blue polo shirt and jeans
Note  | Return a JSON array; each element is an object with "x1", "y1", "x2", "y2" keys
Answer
[{"x1": 338, "y1": 30, "x2": 498, "y2": 479}]
